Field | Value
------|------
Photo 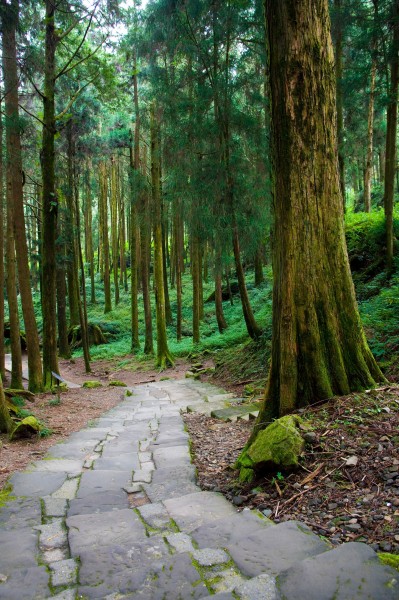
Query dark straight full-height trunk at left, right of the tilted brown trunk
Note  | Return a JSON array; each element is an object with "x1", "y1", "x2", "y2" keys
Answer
[{"x1": 41, "y1": 0, "x2": 58, "y2": 389}]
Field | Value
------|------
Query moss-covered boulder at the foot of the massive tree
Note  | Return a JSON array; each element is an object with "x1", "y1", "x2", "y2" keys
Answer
[{"x1": 245, "y1": 415, "x2": 305, "y2": 470}]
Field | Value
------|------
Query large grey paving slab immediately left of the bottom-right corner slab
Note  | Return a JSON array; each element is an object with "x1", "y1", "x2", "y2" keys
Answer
[{"x1": 226, "y1": 521, "x2": 330, "y2": 577}]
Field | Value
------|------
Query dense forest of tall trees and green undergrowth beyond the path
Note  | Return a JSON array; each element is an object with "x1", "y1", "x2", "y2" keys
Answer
[{"x1": 0, "y1": 0, "x2": 399, "y2": 431}]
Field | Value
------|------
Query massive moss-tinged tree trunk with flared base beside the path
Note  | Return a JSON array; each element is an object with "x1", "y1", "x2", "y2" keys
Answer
[{"x1": 256, "y1": 0, "x2": 384, "y2": 428}]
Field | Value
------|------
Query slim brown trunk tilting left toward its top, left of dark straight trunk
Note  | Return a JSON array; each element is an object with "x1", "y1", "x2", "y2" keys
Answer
[{"x1": 2, "y1": 0, "x2": 42, "y2": 393}]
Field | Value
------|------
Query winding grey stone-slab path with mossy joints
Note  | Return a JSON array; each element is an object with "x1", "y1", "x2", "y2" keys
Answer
[{"x1": 0, "y1": 380, "x2": 399, "y2": 600}]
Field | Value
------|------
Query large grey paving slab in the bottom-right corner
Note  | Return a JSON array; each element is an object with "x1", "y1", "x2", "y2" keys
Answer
[{"x1": 277, "y1": 542, "x2": 399, "y2": 600}]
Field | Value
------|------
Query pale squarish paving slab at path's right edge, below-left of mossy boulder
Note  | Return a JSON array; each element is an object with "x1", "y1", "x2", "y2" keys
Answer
[{"x1": 164, "y1": 492, "x2": 236, "y2": 533}]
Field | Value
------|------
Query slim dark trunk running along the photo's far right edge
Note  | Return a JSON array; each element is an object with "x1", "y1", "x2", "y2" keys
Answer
[{"x1": 384, "y1": 0, "x2": 399, "y2": 277}]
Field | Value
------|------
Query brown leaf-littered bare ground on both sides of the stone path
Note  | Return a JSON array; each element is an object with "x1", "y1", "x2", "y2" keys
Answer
[{"x1": 0, "y1": 359, "x2": 399, "y2": 552}]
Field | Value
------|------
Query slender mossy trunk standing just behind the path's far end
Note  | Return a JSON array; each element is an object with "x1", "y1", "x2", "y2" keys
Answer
[{"x1": 151, "y1": 102, "x2": 173, "y2": 369}]
